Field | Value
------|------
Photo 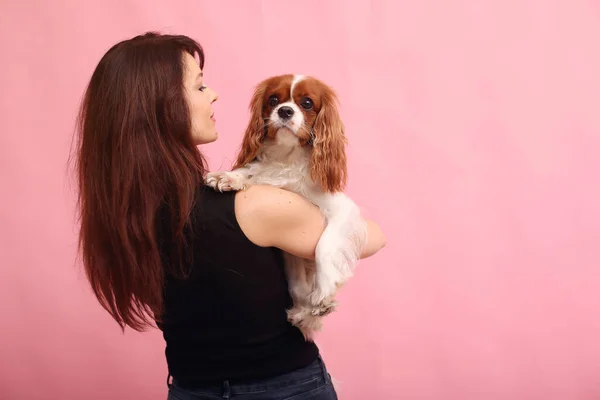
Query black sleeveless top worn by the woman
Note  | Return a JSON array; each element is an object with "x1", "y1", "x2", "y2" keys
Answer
[{"x1": 159, "y1": 186, "x2": 318, "y2": 386}]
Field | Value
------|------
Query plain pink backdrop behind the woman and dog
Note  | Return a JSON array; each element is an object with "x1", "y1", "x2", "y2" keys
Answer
[{"x1": 0, "y1": 0, "x2": 600, "y2": 400}]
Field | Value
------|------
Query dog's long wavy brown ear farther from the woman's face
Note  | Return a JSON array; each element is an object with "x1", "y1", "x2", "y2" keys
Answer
[{"x1": 310, "y1": 84, "x2": 347, "y2": 192}]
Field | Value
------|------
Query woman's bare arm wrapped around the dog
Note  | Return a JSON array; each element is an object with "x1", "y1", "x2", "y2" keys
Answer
[{"x1": 235, "y1": 186, "x2": 386, "y2": 259}]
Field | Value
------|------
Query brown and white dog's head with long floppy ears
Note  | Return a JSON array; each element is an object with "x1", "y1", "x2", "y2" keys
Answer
[{"x1": 234, "y1": 75, "x2": 347, "y2": 192}]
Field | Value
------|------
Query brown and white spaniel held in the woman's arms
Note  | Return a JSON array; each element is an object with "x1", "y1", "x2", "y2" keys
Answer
[{"x1": 206, "y1": 75, "x2": 367, "y2": 340}]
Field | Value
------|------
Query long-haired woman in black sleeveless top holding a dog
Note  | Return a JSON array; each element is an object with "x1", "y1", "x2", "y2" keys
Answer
[{"x1": 77, "y1": 33, "x2": 385, "y2": 400}]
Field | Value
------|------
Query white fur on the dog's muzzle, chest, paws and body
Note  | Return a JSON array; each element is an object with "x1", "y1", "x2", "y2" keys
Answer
[{"x1": 206, "y1": 74, "x2": 367, "y2": 340}]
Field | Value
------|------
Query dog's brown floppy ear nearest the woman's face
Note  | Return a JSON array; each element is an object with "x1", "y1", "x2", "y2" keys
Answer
[{"x1": 233, "y1": 81, "x2": 267, "y2": 169}]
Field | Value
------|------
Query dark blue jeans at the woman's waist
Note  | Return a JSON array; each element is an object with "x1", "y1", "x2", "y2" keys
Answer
[{"x1": 167, "y1": 357, "x2": 337, "y2": 400}]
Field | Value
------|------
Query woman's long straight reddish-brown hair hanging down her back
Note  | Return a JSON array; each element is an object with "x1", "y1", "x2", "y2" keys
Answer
[{"x1": 75, "y1": 32, "x2": 206, "y2": 331}]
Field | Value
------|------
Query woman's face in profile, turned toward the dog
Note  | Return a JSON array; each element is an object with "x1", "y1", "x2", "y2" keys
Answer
[{"x1": 183, "y1": 53, "x2": 219, "y2": 145}]
